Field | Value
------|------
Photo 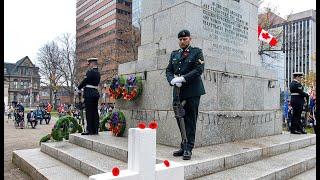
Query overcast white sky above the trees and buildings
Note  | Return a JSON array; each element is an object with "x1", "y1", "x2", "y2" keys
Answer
[{"x1": 4, "y1": 0, "x2": 316, "y2": 63}]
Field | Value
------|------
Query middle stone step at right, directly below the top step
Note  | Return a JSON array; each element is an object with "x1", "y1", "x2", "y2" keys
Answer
[{"x1": 197, "y1": 145, "x2": 316, "y2": 180}]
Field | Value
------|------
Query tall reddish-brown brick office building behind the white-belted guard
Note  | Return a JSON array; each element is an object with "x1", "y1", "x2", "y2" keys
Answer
[{"x1": 76, "y1": 0, "x2": 140, "y2": 92}]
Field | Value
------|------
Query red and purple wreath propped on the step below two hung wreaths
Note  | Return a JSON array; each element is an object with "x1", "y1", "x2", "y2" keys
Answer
[{"x1": 108, "y1": 111, "x2": 126, "y2": 137}]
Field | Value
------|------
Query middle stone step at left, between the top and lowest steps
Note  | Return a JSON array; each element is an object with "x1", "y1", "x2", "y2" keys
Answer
[{"x1": 41, "y1": 141, "x2": 127, "y2": 176}]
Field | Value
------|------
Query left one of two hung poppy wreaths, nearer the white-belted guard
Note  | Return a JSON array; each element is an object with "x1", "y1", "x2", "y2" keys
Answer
[{"x1": 107, "y1": 76, "x2": 125, "y2": 99}]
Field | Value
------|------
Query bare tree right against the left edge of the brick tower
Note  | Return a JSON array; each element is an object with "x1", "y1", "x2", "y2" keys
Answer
[{"x1": 58, "y1": 33, "x2": 77, "y2": 103}]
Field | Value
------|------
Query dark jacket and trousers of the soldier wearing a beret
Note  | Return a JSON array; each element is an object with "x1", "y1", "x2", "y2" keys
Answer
[{"x1": 166, "y1": 46, "x2": 206, "y2": 151}]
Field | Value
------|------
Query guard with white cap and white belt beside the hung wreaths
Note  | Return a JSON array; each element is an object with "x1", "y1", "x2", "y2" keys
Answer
[{"x1": 78, "y1": 58, "x2": 100, "y2": 135}]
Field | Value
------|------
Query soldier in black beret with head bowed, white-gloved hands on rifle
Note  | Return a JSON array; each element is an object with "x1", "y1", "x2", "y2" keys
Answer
[{"x1": 166, "y1": 30, "x2": 205, "y2": 160}]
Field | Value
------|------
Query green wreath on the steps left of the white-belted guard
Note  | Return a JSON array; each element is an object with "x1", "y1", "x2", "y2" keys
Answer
[{"x1": 40, "y1": 116, "x2": 83, "y2": 143}]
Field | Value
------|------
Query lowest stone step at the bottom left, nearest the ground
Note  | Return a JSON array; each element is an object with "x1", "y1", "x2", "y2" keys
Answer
[{"x1": 12, "y1": 148, "x2": 89, "y2": 180}]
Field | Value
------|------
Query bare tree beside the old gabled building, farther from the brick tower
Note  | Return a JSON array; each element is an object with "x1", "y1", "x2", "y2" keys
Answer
[{"x1": 37, "y1": 41, "x2": 62, "y2": 108}]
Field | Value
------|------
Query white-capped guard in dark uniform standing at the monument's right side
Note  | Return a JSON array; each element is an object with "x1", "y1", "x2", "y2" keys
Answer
[{"x1": 290, "y1": 72, "x2": 309, "y2": 134}]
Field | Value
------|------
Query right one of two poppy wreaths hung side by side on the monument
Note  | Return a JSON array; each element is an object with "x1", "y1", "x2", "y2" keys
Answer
[{"x1": 122, "y1": 75, "x2": 142, "y2": 101}]
